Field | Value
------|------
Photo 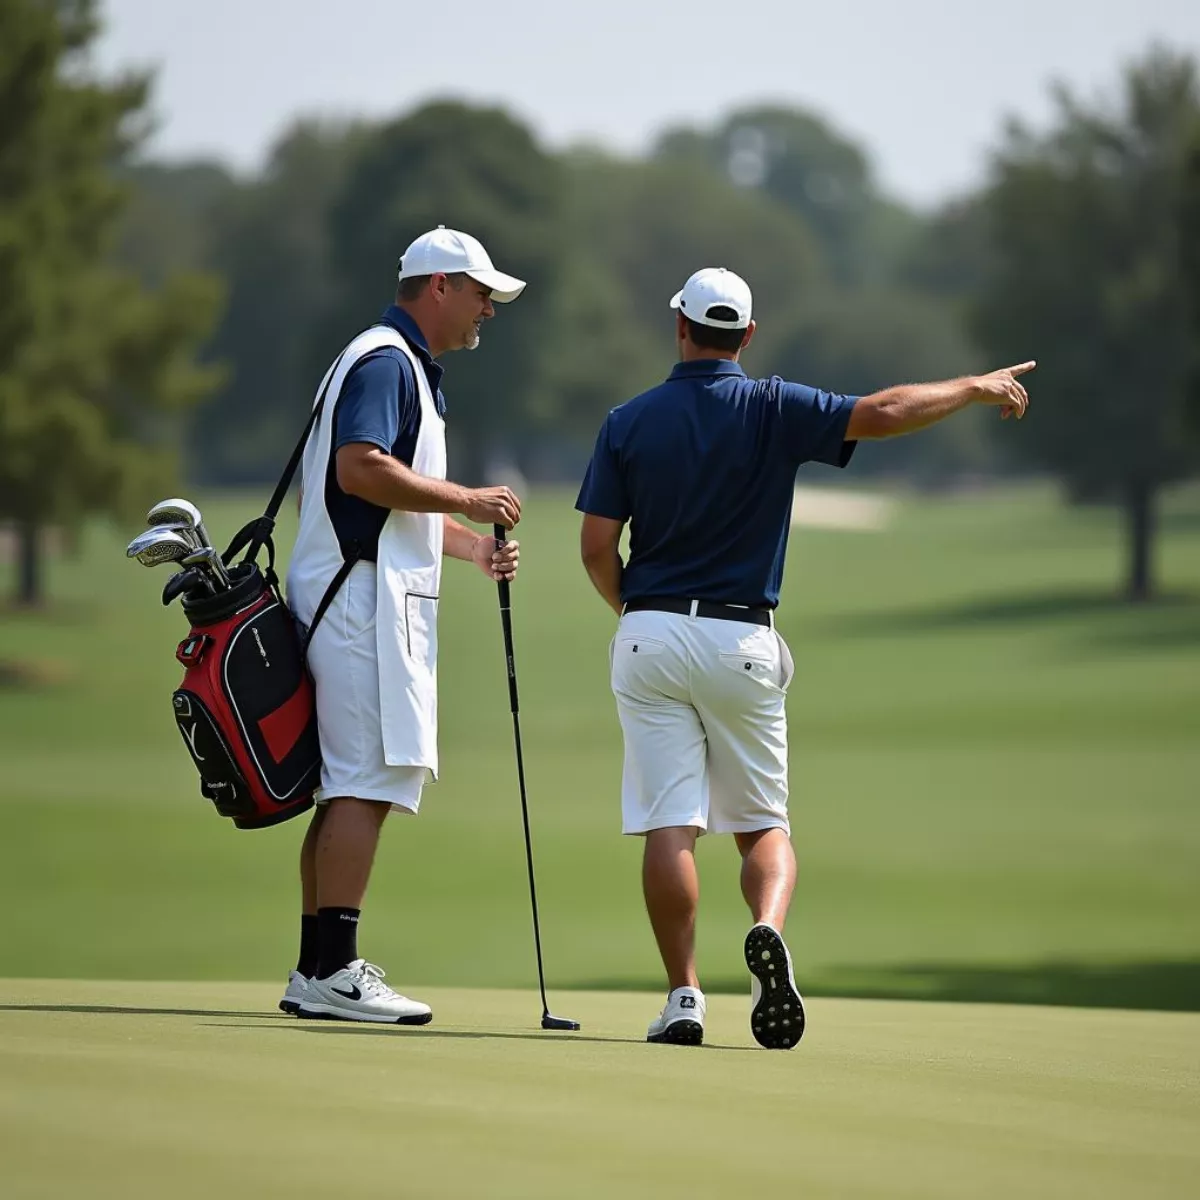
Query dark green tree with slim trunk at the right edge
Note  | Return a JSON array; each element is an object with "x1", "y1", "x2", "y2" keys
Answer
[{"x1": 976, "y1": 49, "x2": 1200, "y2": 600}]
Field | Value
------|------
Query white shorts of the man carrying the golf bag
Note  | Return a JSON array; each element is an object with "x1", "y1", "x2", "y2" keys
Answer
[{"x1": 308, "y1": 563, "x2": 427, "y2": 814}]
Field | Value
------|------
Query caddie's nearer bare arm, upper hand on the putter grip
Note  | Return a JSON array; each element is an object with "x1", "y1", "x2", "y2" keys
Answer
[{"x1": 337, "y1": 442, "x2": 521, "y2": 529}]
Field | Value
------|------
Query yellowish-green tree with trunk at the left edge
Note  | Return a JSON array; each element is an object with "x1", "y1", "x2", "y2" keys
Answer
[{"x1": 0, "y1": 0, "x2": 217, "y2": 604}]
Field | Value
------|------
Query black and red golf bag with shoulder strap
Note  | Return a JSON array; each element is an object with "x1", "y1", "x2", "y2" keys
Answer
[{"x1": 172, "y1": 357, "x2": 358, "y2": 829}]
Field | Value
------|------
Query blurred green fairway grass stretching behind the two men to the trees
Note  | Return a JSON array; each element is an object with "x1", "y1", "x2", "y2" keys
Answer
[{"x1": 0, "y1": 491, "x2": 1200, "y2": 1019}]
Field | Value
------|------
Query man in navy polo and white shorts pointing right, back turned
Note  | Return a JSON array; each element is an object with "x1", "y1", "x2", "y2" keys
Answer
[{"x1": 576, "y1": 268, "x2": 1033, "y2": 1049}]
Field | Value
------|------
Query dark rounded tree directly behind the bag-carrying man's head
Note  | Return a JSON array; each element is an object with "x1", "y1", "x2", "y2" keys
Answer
[{"x1": 311, "y1": 102, "x2": 563, "y2": 480}]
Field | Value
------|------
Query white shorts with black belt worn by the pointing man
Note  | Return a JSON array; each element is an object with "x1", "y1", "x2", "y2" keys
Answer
[{"x1": 611, "y1": 611, "x2": 796, "y2": 834}]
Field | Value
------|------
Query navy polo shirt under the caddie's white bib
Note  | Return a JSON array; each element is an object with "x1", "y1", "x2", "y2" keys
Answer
[{"x1": 325, "y1": 305, "x2": 445, "y2": 560}]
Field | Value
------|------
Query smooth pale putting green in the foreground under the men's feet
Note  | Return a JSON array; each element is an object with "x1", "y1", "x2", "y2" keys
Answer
[{"x1": 0, "y1": 980, "x2": 1200, "y2": 1200}]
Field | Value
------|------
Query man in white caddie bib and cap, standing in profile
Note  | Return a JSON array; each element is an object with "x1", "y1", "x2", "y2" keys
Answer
[{"x1": 280, "y1": 226, "x2": 524, "y2": 1025}]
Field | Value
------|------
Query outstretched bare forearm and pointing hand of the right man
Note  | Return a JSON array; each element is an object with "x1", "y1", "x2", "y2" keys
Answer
[{"x1": 846, "y1": 362, "x2": 1037, "y2": 442}]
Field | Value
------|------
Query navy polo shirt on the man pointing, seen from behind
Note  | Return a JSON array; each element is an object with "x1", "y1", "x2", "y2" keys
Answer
[{"x1": 575, "y1": 359, "x2": 858, "y2": 607}]
